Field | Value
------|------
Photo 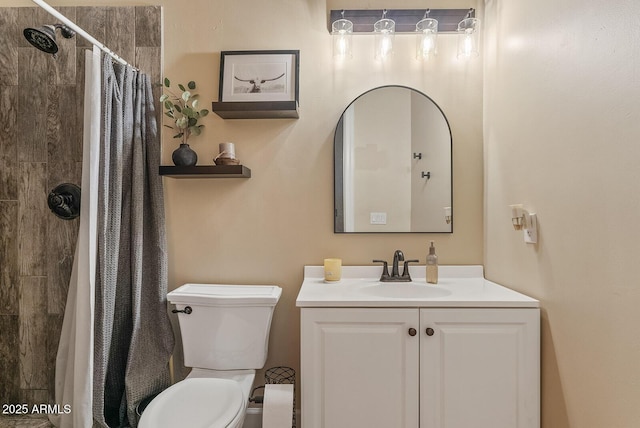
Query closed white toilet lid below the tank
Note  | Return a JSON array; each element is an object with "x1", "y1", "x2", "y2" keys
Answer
[{"x1": 139, "y1": 378, "x2": 244, "y2": 428}]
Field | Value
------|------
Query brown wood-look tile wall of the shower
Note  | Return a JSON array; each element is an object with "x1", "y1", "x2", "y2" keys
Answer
[{"x1": 0, "y1": 6, "x2": 162, "y2": 405}]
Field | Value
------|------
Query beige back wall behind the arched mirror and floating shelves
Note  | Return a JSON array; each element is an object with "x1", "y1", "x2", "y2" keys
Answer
[{"x1": 0, "y1": 0, "x2": 483, "y2": 410}]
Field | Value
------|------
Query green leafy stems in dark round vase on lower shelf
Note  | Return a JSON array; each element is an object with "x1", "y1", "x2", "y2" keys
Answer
[{"x1": 160, "y1": 78, "x2": 209, "y2": 166}]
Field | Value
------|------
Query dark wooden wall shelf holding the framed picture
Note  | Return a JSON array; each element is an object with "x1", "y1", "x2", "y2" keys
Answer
[{"x1": 211, "y1": 101, "x2": 299, "y2": 119}]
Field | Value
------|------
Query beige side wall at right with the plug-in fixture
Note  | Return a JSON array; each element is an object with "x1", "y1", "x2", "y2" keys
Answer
[{"x1": 484, "y1": 0, "x2": 640, "y2": 428}]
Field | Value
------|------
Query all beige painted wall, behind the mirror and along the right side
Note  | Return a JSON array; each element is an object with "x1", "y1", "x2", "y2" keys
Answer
[{"x1": 6, "y1": 0, "x2": 640, "y2": 428}]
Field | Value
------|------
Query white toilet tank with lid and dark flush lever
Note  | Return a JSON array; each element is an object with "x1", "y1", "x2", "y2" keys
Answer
[{"x1": 167, "y1": 284, "x2": 282, "y2": 370}]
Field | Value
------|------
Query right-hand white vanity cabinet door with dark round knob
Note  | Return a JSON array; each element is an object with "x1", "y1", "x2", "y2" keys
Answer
[{"x1": 420, "y1": 308, "x2": 540, "y2": 428}]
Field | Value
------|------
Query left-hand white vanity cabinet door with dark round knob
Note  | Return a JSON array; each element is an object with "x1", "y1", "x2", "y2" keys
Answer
[{"x1": 301, "y1": 308, "x2": 420, "y2": 428}]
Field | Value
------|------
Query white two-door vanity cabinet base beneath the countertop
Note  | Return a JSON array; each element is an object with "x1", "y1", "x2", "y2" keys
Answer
[{"x1": 301, "y1": 307, "x2": 540, "y2": 428}]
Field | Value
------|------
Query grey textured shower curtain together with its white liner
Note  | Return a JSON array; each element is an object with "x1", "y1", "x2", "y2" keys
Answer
[{"x1": 52, "y1": 48, "x2": 174, "y2": 428}]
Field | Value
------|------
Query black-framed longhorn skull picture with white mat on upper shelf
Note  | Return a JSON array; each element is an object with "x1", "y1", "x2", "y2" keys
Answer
[{"x1": 218, "y1": 50, "x2": 300, "y2": 103}]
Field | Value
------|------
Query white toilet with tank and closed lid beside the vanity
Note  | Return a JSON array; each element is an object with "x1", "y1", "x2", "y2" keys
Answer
[{"x1": 138, "y1": 284, "x2": 282, "y2": 428}]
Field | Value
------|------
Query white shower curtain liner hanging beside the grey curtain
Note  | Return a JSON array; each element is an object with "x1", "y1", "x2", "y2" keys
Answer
[{"x1": 49, "y1": 48, "x2": 101, "y2": 428}]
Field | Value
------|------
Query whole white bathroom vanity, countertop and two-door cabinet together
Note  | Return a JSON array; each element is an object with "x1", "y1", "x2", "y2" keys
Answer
[{"x1": 296, "y1": 266, "x2": 540, "y2": 428}]
